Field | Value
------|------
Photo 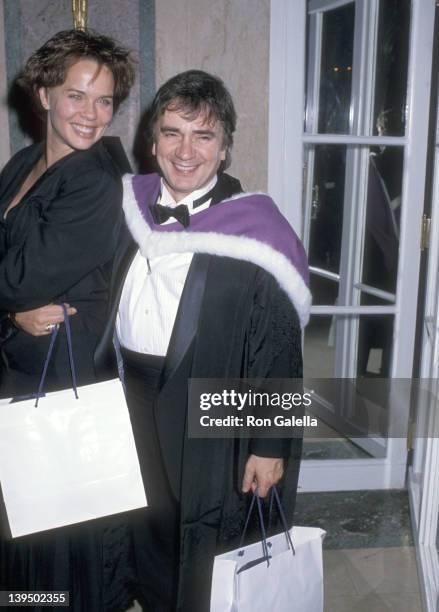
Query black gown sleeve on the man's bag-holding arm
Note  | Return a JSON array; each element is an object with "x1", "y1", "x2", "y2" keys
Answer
[{"x1": 248, "y1": 270, "x2": 303, "y2": 458}]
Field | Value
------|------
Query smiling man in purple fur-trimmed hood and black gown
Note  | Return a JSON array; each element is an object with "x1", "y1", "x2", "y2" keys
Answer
[{"x1": 96, "y1": 70, "x2": 309, "y2": 612}]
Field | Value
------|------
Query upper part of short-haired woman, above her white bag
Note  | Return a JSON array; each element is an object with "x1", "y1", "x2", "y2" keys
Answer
[{"x1": 0, "y1": 30, "x2": 134, "y2": 397}]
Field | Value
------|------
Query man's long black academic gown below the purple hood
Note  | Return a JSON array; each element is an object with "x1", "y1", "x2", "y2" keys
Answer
[{"x1": 96, "y1": 175, "x2": 307, "y2": 612}]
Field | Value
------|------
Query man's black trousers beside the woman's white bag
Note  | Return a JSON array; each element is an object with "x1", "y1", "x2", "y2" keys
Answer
[{"x1": 122, "y1": 349, "x2": 179, "y2": 612}]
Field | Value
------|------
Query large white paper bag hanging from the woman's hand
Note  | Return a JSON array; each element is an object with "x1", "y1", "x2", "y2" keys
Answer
[{"x1": 0, "y1": 379, "x2": 147, "y2": 537}]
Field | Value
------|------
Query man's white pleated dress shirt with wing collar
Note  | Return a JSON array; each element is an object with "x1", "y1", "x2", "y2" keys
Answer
[{"x1": 116, "y1": 176, "x2": 217, "y2": 356}]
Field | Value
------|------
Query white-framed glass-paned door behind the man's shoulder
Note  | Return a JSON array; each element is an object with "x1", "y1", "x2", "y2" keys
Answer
[{"x1": 269, "y1": 0, "x2": 434, "y2": 490}]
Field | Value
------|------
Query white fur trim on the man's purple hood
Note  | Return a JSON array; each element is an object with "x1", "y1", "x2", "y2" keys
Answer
[{"x1": 123, "y1": 174, "x2": 311, "y2": 327}]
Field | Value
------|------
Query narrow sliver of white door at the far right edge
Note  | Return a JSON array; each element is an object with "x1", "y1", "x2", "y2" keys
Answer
[{"x1": 408, "y1": 7, "x2": 439, "y2": 612}]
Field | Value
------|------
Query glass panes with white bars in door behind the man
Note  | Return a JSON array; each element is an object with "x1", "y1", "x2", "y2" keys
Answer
[{"x1": 304, "y1": 0, "x2": 411, "y2": 466}]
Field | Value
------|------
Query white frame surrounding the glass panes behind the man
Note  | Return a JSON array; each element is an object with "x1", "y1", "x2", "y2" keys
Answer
[{"x1": 268, "y1": 0, "x2": 435, "y2": 491}]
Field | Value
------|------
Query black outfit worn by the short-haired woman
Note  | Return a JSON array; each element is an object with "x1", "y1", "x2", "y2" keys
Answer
[{"x1": 0, "y1": 141, "x2": 136, "y2": 612}]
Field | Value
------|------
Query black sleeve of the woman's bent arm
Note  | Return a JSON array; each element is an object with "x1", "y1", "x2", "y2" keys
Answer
[{"x1": 0, "y1": 166, "x2": 122, "y2": 312}]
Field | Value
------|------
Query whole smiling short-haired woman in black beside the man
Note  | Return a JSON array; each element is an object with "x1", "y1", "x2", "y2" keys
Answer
[{"x1": 0, "y1": 30, "x2": 134, "y2": 611}]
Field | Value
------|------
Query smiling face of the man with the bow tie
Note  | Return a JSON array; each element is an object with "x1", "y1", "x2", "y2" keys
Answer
[{"x1": 152, "y1": 110, "x2": 226, "y2": 202}]
